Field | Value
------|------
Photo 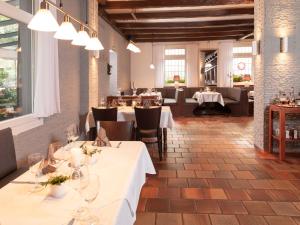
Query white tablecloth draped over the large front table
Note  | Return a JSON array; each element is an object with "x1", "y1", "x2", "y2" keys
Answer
[{"x1": 0, "y1": 142, "x2": 155, "y2": 225}]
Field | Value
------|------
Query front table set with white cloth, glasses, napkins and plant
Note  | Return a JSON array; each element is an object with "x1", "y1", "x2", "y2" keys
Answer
[{"x1": 0, "y1": 141, "x2": 156, "y2": 225}]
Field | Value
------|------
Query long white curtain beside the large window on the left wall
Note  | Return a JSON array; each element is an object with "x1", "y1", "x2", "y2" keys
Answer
[{"x1": 34, "y1": 0, "x2": 60, "y2": 117}]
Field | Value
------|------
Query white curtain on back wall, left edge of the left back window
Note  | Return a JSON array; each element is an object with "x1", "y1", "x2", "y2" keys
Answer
[{"x1": 153, "y1": 45, "x2": 165, "y2": 88}]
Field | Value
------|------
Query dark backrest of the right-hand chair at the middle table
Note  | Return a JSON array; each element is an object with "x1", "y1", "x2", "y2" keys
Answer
[{"x1": 134, "y1": 107, "x2": 161, "y2": 130}]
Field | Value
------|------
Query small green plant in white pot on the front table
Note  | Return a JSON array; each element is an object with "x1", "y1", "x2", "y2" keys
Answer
[{"x1": 42, "y1": 175, "x2": 70, "y2": 198}]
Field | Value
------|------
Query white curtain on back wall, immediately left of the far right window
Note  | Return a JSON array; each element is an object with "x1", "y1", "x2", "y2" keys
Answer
[{"x1": 218, "y1": 41, "x2": 233, "y2": 87}]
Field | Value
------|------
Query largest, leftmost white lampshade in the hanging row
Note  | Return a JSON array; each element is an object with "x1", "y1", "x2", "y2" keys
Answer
[{"x1": 27, "y1": 8, "x2": 59, "y2": 32}]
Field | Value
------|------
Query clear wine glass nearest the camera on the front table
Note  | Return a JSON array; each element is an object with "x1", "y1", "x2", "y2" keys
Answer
[{"x1": 79, "y1": 174, "x2": 100, "y2": 225}]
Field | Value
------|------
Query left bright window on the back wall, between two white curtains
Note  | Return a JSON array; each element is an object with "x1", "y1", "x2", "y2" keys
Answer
[{"x1": 164, "y1": 48, "x2": 186, "y2": 84}]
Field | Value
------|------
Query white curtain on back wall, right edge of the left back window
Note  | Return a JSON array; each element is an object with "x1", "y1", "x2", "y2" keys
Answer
[{"x1": 186, "y1": 44, "x2": 199, "y2": 87}]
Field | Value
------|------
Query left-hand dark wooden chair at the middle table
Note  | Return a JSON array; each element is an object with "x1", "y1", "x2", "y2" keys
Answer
[{"x1": 88, "y1": 107, "x2": 118, "y2": 141}]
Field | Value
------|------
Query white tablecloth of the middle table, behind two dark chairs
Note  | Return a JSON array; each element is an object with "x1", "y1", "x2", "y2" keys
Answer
[{"x1": 85, "y1": 106, "x2": 174, "y2": 132}]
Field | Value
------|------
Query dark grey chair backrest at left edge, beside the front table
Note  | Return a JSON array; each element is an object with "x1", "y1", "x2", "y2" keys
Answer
[{"x1": 0, "y1": 128, "x2": 17, "y2": 179}]
